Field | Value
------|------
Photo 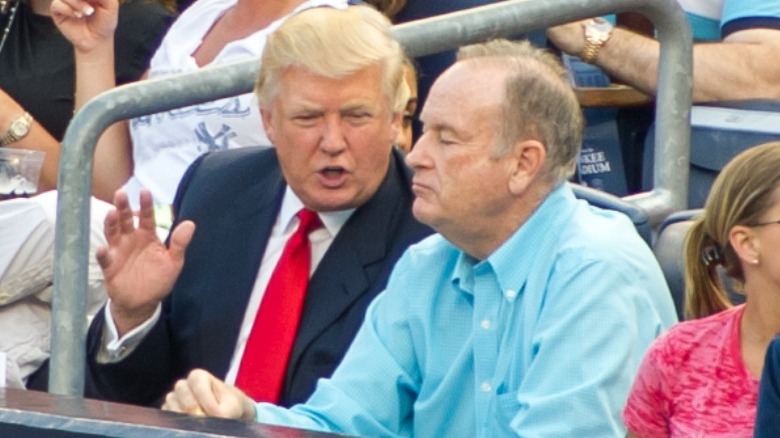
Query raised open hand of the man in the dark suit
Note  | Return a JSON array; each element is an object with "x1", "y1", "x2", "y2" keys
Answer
[{"x1": 96, "y1": 190, "x2": 195, "y2": 336}]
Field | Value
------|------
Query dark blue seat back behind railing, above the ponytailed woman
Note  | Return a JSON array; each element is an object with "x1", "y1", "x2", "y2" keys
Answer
[{"x1": 642, "y1": 100, "x2": 780, "y2": 208}]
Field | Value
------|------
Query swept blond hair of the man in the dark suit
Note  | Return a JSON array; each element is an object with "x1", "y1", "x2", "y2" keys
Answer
[{"x1": 255, "y1": 6, "x2": 409, "y2": 111}]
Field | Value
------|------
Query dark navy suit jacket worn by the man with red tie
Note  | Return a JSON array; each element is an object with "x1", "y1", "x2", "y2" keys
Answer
[{"x1": 86, "y1": 148, "x2": 431, "y2": 406}]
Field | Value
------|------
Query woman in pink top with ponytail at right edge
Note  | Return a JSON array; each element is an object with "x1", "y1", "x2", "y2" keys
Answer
[{"x1": 623, "y1": 143, "x2": 780, "y2": 438}]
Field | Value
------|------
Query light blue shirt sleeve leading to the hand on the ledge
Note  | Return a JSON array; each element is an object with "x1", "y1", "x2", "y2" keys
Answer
[{"x1": 256, "y1": 252, "x2": 421, "y2": 436}]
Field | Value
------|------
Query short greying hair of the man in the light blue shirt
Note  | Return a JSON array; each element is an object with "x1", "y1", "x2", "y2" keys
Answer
[{"x1": 458, "y1": 39, "x2": 584, "y2": 183}]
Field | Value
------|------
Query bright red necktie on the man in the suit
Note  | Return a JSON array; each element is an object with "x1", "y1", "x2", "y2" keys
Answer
[{"x1": 236, "y1": 208, "x2": 322, "y2": 403}]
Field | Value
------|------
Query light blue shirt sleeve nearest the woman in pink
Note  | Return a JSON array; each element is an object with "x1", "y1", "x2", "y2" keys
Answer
[{"x1": 511, "y1": 245, "x2": 675, "y2": 437}]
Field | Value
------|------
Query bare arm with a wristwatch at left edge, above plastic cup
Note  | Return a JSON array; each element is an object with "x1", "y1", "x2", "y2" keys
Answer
[{"x1": 0, "y1": 89, "x2": 60, "y2": 192}]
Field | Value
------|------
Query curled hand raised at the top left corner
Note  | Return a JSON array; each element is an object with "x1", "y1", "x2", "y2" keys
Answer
[{"x1": 50, "y1": 0, "x2": 119, "y2": 52}]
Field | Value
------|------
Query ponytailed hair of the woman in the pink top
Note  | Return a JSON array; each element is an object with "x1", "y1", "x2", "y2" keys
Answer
[{"x1": 685, "y1": 142, "x2": 780, "y2": 318}]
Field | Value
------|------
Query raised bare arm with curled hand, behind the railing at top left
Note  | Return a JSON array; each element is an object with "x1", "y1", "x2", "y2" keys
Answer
[{"x1": 51, "y1": 0, "x2": 133, "y2": 202}]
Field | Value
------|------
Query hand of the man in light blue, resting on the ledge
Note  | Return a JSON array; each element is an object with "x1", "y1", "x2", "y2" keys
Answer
[{"x1": 162, "y1": 369, "x2": 255, "y2": 421}]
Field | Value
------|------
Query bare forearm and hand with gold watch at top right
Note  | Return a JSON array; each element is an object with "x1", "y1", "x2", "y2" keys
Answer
[{"x1": 547, "y1": 22, "x2": 780, "y2": 102}]
